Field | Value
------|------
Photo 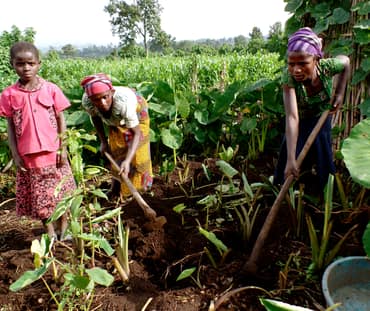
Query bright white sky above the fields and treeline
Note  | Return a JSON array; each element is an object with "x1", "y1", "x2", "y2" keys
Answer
[{"x1": 0, "y1": 0, "x2": 289, "y2": 48}]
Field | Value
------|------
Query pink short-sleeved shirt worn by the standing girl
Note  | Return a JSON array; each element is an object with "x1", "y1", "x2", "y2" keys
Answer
[{"x1": 0, "y1": 79, "x2": 71, "y2": 156}]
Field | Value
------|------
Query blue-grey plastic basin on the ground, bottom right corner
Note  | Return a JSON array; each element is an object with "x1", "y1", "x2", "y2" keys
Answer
[{"x1": 321, "y1": 256, "x2": 370, "y2": 311}]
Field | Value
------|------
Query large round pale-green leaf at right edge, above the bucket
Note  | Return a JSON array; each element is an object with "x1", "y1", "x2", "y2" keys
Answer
[{"x1": 341, "y1": 119, "x2": 370, "y2": 188}]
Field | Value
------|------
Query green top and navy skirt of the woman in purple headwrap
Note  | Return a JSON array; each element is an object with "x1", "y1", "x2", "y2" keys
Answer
[{"x1": 274, "y1": 58, "x2": 344, "y2": 190}]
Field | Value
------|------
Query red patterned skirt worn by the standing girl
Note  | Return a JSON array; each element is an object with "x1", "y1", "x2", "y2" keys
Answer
[{"x1": 16, "y1": 152, "x2": 76, "y2": 220}]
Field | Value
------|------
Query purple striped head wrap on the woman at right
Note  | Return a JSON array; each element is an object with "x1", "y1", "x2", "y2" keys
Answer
[{"x1": 288, "y1": 27, "x2": 323, "y2": 58}]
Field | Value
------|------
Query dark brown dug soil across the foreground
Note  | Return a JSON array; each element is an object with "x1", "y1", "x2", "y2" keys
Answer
[{"x1": 0, "y1": 159, "x2": 368, "y2": 311}]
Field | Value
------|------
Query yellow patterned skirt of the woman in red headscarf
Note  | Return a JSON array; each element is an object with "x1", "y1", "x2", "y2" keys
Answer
[{"x1": 109, "y1": 95, "x2": 153, "y2": 197}]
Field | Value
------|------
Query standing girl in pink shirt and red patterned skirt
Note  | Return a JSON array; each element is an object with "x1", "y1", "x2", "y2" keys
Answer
[{"x1": 0, "y1": 42, "x2": 76, "y2": 239}]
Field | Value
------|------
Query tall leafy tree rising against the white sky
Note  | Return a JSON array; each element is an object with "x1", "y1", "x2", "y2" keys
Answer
[{"x1": 104, "y1": 0, "x2": 169, "y2": 55}]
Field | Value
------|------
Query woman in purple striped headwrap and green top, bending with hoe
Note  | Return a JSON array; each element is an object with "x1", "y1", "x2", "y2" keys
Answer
[{"x1": 274, "y1": 27, "x2": 350, "y2": 191}]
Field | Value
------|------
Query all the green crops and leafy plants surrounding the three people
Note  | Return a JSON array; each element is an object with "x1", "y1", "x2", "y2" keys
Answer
[{"x1": 0, "y1": 0, "x2": 370, "y2": 310}]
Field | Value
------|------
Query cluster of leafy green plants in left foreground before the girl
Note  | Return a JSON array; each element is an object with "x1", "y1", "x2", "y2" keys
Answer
[{"x1": 12, "y1": 127, "x2": 133, "y2": 310}]
